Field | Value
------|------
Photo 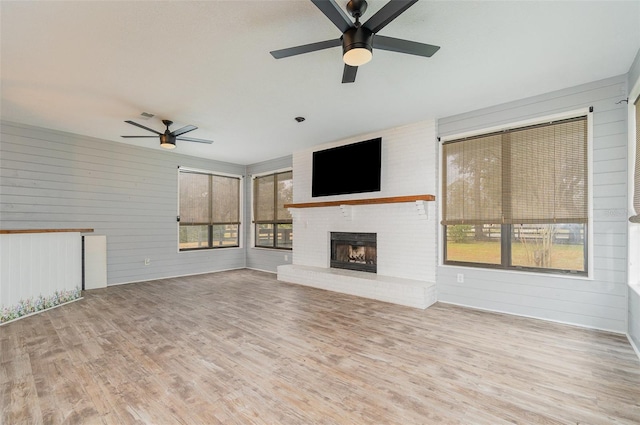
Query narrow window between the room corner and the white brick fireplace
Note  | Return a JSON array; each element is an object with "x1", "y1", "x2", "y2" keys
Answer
[{"x1": 253, "y1": 171, "x2": 293, "y2": 249}]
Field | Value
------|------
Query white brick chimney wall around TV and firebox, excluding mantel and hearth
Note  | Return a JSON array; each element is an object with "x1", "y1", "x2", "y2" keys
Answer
[{"x1": 293, "y1": 121, "x2": 437, "y2": 282}]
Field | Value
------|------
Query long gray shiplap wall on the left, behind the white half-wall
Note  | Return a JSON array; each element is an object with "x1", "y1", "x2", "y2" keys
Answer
[{"x1": 0, "y1": 122, "x2": 247, "y2": 285}]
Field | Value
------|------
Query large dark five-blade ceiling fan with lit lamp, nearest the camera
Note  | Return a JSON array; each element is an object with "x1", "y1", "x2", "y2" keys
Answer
[{"x1": 271, "y1": 0, "x2": 440, "y2": 83}]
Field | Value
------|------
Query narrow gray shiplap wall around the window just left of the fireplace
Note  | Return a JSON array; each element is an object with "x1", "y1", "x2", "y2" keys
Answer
[{"x1": 244, "y1": 155, "x2": 295, "y2": 273}]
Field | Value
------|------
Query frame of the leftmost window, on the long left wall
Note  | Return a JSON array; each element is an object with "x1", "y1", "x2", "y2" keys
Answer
[{"x1": 176, "y1": 166, "x2": 244, "y2": 253}]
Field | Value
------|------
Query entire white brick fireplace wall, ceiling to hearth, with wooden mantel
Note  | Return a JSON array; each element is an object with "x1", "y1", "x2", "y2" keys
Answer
[{"x1": 278, "y1": 120, "x2": 438, "y2": 309}]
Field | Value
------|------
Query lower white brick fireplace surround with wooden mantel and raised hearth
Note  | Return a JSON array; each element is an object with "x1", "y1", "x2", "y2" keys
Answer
[{"x1": 278, "y1": 195, "x2": 437, "y2": 309}]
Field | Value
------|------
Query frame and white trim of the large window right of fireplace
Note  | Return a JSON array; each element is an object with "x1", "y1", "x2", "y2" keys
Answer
[{"x1": 438, "y1": 107, "x2": 594, "y2": 279}]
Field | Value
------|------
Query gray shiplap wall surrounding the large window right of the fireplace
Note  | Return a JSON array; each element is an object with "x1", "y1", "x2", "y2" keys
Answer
[{"x1": 437, "y1": 75, "x2": 628, "y2": 333}]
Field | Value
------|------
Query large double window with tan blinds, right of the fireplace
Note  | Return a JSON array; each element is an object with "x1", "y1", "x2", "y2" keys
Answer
[{"x1": 442, "y1": 116, "x2": 589, "y2": 274}]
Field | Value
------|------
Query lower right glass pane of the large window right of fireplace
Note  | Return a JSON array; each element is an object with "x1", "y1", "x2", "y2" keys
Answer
[{"x1": 511, "y1": 223, "x2": 585, "y2": 272}]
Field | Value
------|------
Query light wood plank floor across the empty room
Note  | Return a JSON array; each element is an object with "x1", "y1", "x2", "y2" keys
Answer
[{"x1": 0, "y1": 270, "x2": 640, "y2": 425}]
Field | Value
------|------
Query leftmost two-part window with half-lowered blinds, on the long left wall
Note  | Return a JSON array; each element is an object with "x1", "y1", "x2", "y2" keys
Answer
[{"x1": 179, "y1": 169, "x2": 240, "y2": 251}]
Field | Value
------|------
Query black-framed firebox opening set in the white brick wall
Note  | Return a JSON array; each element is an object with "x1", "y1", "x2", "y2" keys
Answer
[{"x1": 331, "y1": 232, "x2": 377, "y2": 273}]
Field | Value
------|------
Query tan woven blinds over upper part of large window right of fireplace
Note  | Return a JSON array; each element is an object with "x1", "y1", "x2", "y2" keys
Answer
[{"x1": 442, "y1": 116, "x2": 588, "y2": 225}]
